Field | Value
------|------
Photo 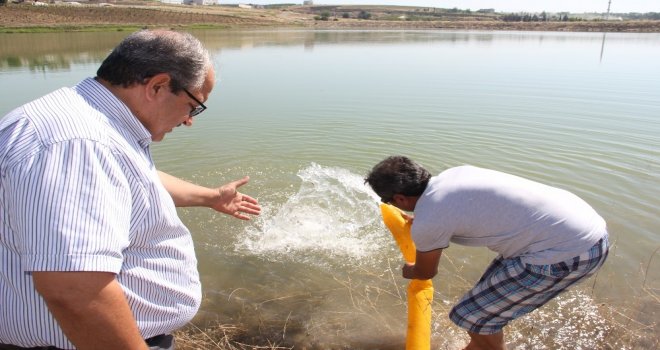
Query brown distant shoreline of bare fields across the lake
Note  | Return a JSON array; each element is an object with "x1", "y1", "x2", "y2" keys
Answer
[{"x1": 0, "y1": 2, "x2": 660, "y2": 33}]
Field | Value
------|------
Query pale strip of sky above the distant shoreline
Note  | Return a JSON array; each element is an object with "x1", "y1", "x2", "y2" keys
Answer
[{"x1": 246, "y1": 0, "x2": 660, "y2": 13}]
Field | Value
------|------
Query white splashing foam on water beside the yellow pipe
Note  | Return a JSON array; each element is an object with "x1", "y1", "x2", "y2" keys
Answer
[{"x1": 237, "y1": 163, "x2": 388, "y2": 266}]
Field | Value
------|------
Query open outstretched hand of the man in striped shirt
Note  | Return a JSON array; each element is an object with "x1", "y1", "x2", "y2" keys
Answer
[{"x1": 211, "y1": 176, "x2": 261, "y2": 220}]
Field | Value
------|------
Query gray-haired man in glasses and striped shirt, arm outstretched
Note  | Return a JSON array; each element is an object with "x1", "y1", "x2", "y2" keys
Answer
[{"x1": 0, "y1": 30, "x2": 260, "y2": 349}]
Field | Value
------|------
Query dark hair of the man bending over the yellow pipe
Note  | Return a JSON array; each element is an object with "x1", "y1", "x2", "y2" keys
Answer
[{"x1": 364, "y1": 156, "x2": 431, "y2": 203}]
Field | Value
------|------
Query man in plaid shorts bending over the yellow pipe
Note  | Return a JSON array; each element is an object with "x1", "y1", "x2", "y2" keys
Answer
[{"x1": 366, "y1": 156, "x2": 608, "y2": 350}]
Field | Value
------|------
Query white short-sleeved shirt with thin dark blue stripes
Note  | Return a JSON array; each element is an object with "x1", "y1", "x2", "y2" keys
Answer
[{"x1": 0, "y1": 79, "x2": 201, "y2": 348}]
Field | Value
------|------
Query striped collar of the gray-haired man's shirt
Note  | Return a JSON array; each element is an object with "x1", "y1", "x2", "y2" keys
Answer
[{"x1": 73, "y1": 78, "x2": 152, "y2": 148}]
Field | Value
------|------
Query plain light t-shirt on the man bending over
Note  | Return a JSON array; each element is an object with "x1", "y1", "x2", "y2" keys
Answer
[{"x1": 412, "y1": 166, "x2": 607, "y2": 265}]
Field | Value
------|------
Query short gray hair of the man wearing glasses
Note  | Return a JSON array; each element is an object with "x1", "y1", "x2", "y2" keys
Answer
[{"x1": 96, "y1": 29, "x2": 211, "y2": 93}]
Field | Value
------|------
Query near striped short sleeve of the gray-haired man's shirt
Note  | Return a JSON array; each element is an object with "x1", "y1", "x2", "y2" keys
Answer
[{"x1": 5, "y1": 140, "x2": 131, "y2": 273}]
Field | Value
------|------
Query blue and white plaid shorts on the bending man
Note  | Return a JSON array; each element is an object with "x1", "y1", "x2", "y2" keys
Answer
[{"x1": 449, "y1": 236, "x2": 609, "y2": 334}]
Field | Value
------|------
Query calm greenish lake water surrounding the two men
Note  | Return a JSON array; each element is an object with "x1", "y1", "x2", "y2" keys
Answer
[{"x1": 0, "y1": 30, "x2": 660, "y2": 349}]
